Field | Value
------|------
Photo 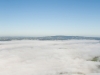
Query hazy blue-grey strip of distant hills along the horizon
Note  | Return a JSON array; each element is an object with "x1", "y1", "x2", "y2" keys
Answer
[{"x1": 0, "y1": 36, "x2": 100, "y2": 41}]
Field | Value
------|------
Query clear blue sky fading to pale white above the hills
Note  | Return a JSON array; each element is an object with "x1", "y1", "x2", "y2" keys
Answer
[{"x1": 0, "y1": 0, "x2": 100, "y2": 37}]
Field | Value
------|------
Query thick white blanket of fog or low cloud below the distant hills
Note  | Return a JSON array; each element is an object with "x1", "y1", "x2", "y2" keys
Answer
[{"x1": 0, "y1": 40, "x2": 100, "y2": 75}]
